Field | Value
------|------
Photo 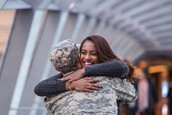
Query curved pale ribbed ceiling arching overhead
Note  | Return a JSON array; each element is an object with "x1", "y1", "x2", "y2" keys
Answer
[{"x1": 1, "y1": 0, "x2": 172, "y2": 61}]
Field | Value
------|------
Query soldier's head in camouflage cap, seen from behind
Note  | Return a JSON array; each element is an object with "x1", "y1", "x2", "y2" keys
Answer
[{"x1": 49, "y1": 39, "x2": 78, "y2": 73}]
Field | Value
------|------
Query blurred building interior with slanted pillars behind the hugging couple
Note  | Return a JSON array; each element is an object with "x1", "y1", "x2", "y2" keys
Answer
[{"x1": 0, "y1": 0, "x2": 172, "y2": 115}]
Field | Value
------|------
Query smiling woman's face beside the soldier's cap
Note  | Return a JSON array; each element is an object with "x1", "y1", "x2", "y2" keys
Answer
[{"x1": 80, "y1": 40, "x2": 99, "y2": 67}]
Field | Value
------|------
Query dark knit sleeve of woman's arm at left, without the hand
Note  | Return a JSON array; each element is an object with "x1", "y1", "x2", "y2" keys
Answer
[{"x1": 34, "y1": 73, "x2": 67, "y2": 96}]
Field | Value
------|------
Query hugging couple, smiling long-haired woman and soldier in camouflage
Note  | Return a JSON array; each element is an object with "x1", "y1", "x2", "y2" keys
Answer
[{"x1": 34, "y1": 35, "x2": 137, "y2": 115}]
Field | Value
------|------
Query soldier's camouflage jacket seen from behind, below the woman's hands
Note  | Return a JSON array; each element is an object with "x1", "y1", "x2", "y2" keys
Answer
[{"x1": 44, "y1": 77, "x2": 137, "y2": 115}]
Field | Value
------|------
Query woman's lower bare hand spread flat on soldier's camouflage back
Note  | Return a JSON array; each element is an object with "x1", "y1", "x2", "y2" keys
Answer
[{"x1": 71, "y1": 77, "x2": 101, "y2": 93}]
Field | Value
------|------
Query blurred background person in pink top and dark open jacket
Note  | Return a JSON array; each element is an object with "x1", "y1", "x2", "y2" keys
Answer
[{"x1": 128, "y1": 68, "x2": 158, "y2": 115}]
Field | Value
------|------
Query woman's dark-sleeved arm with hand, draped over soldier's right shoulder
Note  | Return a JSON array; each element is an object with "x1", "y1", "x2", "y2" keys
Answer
[{"x1": 63, "y1": 60, "x2": 129, "y2": 82}]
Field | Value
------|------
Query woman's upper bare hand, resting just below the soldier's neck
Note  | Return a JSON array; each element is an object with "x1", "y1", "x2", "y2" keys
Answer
[{"x1": 61, "y1": 68, "x2": 85, "y2": 82}]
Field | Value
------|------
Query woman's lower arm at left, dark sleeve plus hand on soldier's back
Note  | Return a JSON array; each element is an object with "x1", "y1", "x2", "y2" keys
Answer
[{"x1": 34, "y1": 74, "x2": 101, "y2": 96}]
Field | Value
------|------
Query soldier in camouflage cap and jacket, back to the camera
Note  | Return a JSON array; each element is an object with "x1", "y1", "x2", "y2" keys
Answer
[{"x1": 44, "y1": 40, "x2": 137, "y2": 115}]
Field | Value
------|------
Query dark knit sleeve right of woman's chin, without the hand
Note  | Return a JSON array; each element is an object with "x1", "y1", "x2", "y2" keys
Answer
[{"x1": 85, "y1": 60, "x2": 129, "y2": 79}]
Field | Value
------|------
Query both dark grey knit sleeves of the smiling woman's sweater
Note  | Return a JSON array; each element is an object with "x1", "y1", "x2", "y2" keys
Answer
[{"x1": 34, "y1": 60, "x2": 129, "y2": 96}]
